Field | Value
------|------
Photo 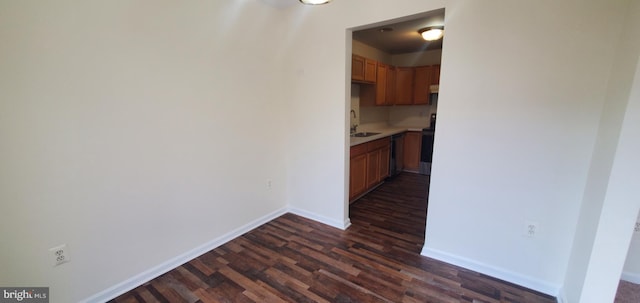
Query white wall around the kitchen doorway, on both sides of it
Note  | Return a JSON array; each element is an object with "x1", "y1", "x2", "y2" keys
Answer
[{"x1": 286, "y1": 0, "x2": 623, "y2": 300}]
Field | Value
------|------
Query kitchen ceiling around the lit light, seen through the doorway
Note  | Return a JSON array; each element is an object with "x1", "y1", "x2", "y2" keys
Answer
[{"x1": 353, "y1": 9, "x2": 447, "y2": 55}]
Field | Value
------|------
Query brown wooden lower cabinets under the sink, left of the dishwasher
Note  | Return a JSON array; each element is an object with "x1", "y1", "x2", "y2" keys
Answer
[{"x1": 349, "y1": 137, "x2": 391, "y2": 202}]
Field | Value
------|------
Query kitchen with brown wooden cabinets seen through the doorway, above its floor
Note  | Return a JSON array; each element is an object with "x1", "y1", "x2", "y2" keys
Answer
[{"x1": 349, "y1": 9, "x2": 444, "y2": 203}]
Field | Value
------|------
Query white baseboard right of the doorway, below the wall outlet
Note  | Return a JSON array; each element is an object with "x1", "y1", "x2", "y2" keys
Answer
[{"x1": 420, "y1": 246, "x2": 561, "y2": 299}]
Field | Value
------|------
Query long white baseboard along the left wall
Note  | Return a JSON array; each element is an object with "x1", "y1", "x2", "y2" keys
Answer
[{"x1": 80, "y1": 208, "x2": 287, "y2": 303}]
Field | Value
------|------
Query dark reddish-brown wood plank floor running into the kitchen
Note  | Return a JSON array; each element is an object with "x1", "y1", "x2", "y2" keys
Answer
[{"x1": 111, "y1": 173, "x2": 556, "y2": 303}]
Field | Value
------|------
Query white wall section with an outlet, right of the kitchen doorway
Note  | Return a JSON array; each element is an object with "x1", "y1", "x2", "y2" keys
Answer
[{"x1": 424, "y1": 1, "x2": 623, "y2": 294}]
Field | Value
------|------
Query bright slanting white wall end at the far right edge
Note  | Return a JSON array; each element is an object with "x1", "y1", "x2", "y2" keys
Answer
[{"x1": 580, "y1": 51, "x2": 640, "y2": 303}]
